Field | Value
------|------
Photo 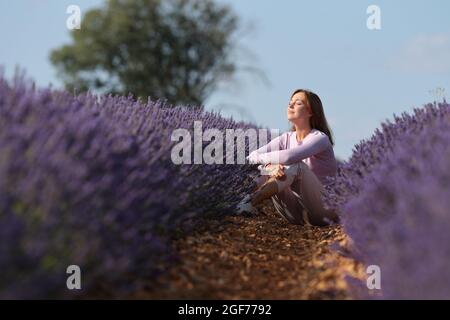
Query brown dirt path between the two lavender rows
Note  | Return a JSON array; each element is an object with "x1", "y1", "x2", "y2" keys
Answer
[{"x1": 134, "y1": 201, "x2": 363, "y2": 299}]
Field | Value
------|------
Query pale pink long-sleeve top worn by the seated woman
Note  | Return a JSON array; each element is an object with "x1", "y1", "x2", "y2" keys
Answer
[{"x1": 256, "y1": 129, "x2": 337, "y2": 185}]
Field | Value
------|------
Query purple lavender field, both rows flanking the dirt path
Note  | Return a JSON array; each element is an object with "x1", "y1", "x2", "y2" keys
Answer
[{"x1": 0, "y1": 76, "x2": 450, "y2": 299}]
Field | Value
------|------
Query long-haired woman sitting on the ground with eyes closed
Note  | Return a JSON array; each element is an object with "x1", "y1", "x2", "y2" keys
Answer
[{"x1": 238, "y1": 89, "x2": 337, "y2": 226}]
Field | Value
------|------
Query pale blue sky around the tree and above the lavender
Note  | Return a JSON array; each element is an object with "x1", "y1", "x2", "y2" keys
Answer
[{"x1": 0, "y1": 0, "x2": 450, "y2": 159}]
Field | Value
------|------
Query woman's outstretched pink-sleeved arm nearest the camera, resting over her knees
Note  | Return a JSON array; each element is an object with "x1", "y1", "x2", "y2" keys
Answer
[{"x1": 256, "y1": 132, "x2": 330, "y2": 165}]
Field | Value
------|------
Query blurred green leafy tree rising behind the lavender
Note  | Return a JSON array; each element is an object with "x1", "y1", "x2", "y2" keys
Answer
[{"x1": 50, "y1": 0, "x2": 240, "y2": 106}]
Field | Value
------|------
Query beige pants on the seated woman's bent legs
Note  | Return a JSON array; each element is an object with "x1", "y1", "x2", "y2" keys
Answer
[{"x1": 256, "y1": 161, "x2": 337, "y2": 226}]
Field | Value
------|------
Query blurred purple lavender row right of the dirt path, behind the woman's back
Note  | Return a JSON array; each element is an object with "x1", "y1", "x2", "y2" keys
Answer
[{"x1": 326, "y1": 100, "x2": 450, "y2": 299}]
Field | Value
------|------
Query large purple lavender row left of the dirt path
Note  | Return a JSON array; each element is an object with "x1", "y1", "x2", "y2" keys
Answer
[{"x1": 0, "y1": 76, "x2": 254, "y2": 298}]
